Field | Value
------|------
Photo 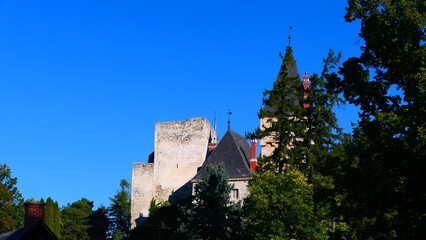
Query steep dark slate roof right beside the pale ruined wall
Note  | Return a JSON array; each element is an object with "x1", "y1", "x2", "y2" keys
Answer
[{"x1": 193, "y1": 130, "x2": 253, "y2": 180}]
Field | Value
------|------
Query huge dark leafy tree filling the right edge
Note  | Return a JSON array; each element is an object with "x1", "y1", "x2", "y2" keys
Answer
[{"x1": 333, "y1": 0, "x2": 426, "y2": 239}]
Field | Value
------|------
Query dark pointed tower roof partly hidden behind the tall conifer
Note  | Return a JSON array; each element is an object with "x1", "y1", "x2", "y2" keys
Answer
[{"x1": 263, "y1": 46, "x2": 303, "y2": 112}]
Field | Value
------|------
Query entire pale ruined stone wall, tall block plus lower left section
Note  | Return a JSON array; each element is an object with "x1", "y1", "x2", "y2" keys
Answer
[{"x1": 131, "y1": 118, "x2": 217, "y2": 228}]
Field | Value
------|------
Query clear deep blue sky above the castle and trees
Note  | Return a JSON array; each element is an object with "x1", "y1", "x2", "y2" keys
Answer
[{"x1": 0, "y1": 0, "x2": 362, "y2": 206}]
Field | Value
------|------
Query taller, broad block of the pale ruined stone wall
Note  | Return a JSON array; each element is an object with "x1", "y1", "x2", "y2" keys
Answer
[{"x1": 154, "y1": 118, "x2": 216, "y2": 201}]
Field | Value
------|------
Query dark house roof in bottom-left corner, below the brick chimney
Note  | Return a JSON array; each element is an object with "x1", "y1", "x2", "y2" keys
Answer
[{"x1": 0, "y1": 221, "x2": 59, "y2": 240}]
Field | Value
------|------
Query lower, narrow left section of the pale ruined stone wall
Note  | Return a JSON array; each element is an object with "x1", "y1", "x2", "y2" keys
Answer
[{"x1": 131, "y1": 163, "x2": 154, "y2": 228}]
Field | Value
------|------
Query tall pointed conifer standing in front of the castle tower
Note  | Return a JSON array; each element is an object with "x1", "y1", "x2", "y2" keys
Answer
[{"x1": 254, "y1": 46, "x2": 306, "y2": 173}]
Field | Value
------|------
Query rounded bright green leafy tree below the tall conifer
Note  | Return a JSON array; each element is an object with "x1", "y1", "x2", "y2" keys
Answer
[{"x1": 244, "y1": 169, "x2": 326, "y2": 240}]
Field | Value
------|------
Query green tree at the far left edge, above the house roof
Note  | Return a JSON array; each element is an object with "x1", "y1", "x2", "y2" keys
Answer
[{"x1": 0, "y1": 163, "x2": 24, "y2": 233}]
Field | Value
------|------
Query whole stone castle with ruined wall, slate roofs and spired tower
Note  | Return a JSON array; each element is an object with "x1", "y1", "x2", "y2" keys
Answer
[{"x1": 131, "y1": 46, "x2": 309, "y2": 228}]
